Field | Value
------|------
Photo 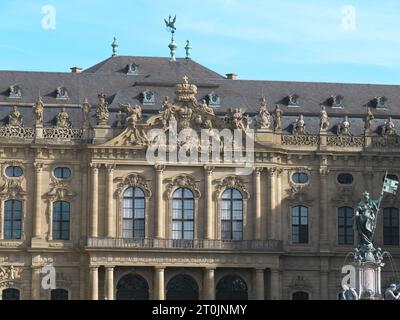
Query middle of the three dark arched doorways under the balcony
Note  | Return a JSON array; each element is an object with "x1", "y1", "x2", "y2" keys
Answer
[{"x1": 166, "y1": 274, "x2": 199, "y2": 300}]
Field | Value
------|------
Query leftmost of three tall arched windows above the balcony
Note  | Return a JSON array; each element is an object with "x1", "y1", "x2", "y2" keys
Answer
[{"x1": 122, "y1": 187, "x2": 145, "y2": 239}]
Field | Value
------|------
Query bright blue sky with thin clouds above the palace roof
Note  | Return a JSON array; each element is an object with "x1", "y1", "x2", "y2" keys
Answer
[{"x1": 0, "y1": 0, "x2": 400, "y2": 84}]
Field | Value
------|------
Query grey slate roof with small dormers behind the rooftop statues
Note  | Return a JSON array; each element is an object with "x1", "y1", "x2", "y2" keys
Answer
[{"x1": 0, "y1": 56, "x2": 400, "y2": 131}]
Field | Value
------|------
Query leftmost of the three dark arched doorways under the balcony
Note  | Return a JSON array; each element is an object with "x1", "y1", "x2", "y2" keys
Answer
[{"x1": 117, "y1": 273, "x2": 149, "y2": 300}]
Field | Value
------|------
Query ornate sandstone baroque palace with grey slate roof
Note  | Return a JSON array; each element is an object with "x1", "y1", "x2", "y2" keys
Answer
[{"x1": 0, "y1": 56, "x2": 400, "y2": 300}]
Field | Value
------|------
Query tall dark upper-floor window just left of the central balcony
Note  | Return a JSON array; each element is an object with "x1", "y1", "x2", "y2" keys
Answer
[{"x1": 53, "y1": 201, "x2": 71, "y2": 240}]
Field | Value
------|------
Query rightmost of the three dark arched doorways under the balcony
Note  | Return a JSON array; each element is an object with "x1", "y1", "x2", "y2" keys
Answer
[{"x1": 216, "y1": 275, "x2": 249, "y2": 300}]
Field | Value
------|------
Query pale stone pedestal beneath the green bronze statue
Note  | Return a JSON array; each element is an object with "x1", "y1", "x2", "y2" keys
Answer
[{"x1": 352, "y1": 261, "x2": 384, "y2": 300}]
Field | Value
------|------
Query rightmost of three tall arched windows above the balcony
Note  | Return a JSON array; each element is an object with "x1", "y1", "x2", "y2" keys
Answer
[{"x1": 221, "y1": 189, "x2": 243, "y2": 240}]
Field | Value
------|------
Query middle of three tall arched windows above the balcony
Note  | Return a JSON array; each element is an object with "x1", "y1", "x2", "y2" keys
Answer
[{"x1": 172, "y1": 188, "x2": 194, "y2": 240}]
